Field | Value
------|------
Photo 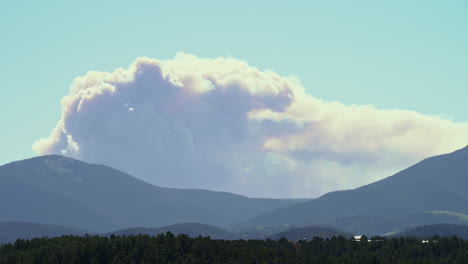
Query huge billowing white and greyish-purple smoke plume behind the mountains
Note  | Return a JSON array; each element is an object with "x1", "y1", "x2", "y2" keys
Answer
[{"x1": 33, "y1": 53, "x2": 468, "y2": 197}]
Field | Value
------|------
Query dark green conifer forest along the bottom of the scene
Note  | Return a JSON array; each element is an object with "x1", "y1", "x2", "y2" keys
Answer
[{"x1": 0, "y1": 232, "x2": 468, "y2": 264}]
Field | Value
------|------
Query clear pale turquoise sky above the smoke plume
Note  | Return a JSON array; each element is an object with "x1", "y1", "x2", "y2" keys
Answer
[{"x1": 0, "y1": 0, "x2": 468, "y2": 167}]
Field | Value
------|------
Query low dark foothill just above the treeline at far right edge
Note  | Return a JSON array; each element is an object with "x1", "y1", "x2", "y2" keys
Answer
[{"x1": 394, "y1": 224, "x2": 468, "y2": 239}]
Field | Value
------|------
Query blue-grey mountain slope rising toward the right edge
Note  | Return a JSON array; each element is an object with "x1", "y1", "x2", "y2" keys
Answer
[{"x1": 236, "y1": 147, "x2": 468, "y2": 227}]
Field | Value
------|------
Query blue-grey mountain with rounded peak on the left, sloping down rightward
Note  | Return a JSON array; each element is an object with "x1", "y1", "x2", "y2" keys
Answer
[{"x1": 0, "y1": 155, "x2": 300, "y2": 232}]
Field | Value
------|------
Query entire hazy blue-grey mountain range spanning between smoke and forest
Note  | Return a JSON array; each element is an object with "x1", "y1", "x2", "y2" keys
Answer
[{"x1": 0, "y1": 147, "x2": 468, "y2": 239}]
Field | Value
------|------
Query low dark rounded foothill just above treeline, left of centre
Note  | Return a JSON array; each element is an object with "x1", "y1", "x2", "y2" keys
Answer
[{"x1": 108, "y1": 223, "x2": 236, "y2": 240}]
